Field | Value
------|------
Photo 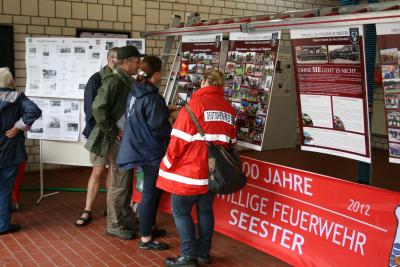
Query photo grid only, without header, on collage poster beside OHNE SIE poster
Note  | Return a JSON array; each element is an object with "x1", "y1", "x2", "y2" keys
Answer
[{"x1": 224, "y1": 48, "x2": 276, "y2": 145}]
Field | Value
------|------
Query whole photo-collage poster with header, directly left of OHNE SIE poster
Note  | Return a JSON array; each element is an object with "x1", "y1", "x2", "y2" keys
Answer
[{"x1": 224, "y1": 32, "x2": 281, "y2": 150}]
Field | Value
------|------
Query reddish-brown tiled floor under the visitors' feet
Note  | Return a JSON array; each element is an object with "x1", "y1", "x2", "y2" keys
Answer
[{"x1": 0, "y1": 168, "x2": 288, "y2": 266}]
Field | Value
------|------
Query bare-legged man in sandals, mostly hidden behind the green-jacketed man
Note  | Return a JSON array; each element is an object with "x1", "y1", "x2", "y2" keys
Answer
[{"x1": 75, "y1": 47, "x2": 118, "y2": 226}]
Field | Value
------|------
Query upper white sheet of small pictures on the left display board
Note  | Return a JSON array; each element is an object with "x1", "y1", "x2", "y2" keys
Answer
[{"x1": 25, "y1": 38, "x2": 101, "y2": 99}]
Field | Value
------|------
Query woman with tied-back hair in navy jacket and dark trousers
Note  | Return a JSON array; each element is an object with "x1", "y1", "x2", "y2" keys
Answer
[{"x1": 117, "y1": 56, "x2": 172, "y2": 251}]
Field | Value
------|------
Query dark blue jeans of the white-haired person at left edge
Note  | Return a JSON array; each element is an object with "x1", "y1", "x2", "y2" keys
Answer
[{"x1": 0, "y1": 164, "x2": 19, "y2": 232}]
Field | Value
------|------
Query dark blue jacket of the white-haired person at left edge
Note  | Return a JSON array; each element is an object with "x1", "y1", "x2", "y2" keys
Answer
[{"x1": 0, "y1": 88, "x2": 42, "y2": 168}]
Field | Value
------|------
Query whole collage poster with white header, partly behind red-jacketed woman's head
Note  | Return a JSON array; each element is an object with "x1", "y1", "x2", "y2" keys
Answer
[{"x1": 176, "y1": 34, "x2": 222, "y2": 106}]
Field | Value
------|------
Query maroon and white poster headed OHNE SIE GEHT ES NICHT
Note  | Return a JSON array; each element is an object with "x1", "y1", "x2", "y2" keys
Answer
[{"x1": 290, "y1": 26, "x2": 371, "y2": 162}]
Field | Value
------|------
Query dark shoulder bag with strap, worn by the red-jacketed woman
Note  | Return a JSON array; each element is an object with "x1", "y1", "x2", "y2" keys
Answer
[{"x1": 185, "y1": 105, "x2": 247, "y2": 195}]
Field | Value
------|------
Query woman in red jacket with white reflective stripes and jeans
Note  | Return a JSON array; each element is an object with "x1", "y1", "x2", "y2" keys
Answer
[{"x1": 157, "y1": 70, "x2": 236, "y2": 266}]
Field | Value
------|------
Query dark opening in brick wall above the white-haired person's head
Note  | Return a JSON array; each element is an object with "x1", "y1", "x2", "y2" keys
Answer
[{"x1": 0, "y1": 25, "x2": 15, "y2": 77}]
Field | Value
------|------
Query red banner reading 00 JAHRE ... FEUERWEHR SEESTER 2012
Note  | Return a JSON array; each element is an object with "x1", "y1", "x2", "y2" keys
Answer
[{"x1": 132, "y1": 157, "x2": 400, "y2": 266}]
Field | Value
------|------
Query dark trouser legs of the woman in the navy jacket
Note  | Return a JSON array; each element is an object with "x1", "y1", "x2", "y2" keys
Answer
[{"x1": 139, "y1": 165, "x2": 162, "y2": 236}]
